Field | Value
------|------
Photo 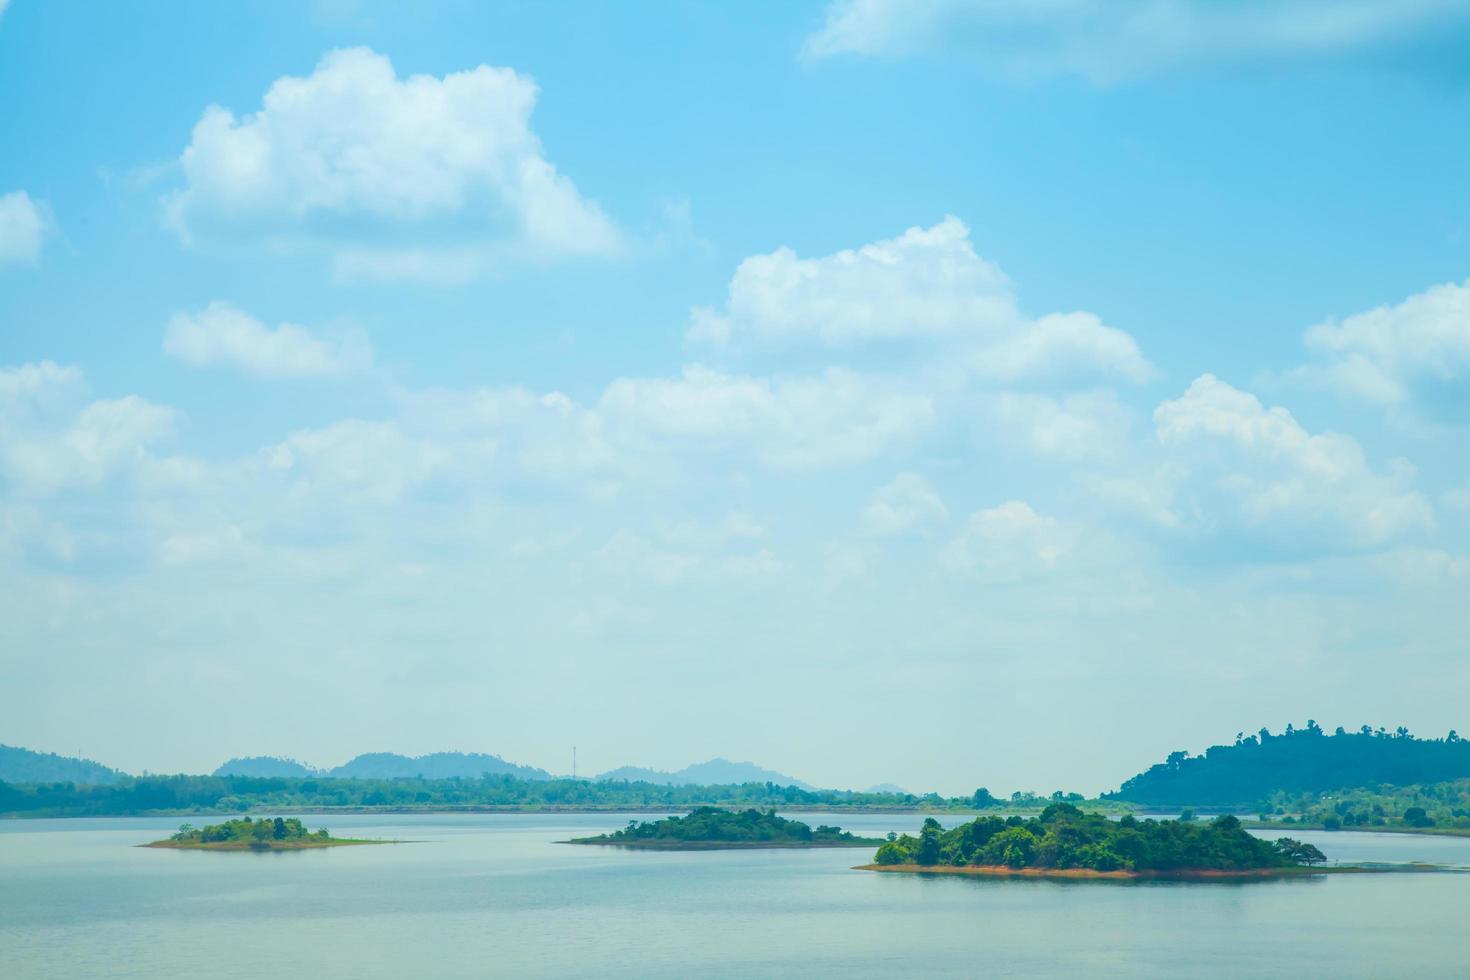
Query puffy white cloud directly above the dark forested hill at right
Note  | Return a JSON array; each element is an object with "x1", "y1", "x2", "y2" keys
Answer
[{"x1": 1154, "y1": 375, "x2": 1435, "y2": 550}]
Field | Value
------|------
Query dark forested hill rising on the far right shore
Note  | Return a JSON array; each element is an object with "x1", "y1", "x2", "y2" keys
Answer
[{"x1": 1105, "y1": 721, "x2": 1470, "y2": 807}]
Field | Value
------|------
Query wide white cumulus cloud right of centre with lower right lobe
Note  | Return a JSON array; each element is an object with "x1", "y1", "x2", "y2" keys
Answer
[{"x1": 689, "y1": 216, "x2": 1151, "y2": 381}]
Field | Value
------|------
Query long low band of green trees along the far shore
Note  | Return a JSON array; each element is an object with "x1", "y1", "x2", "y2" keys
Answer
[{"x1": 0, "y1": 774, "x2": 1130, "y2": 817}]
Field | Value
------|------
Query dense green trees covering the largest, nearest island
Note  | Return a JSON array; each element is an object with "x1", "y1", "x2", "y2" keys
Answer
[{"x1": 875, "y1": 804, "x2": 1326, "y2": 874}]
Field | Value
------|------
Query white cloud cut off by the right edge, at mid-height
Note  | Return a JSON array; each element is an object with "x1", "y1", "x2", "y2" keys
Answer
[{"x1": 1297, "y1": 281, "x2": 1470, "y2": 411}]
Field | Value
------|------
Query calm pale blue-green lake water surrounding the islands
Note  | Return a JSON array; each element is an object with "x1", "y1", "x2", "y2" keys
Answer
[{"x1": 0, "y1": 814, "x2": 1470, "y2": 980}]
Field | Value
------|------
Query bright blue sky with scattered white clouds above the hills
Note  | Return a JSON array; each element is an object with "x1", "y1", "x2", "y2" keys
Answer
[{"x1": 0, "y1": 0, "x2": 1470, "y2": 793}]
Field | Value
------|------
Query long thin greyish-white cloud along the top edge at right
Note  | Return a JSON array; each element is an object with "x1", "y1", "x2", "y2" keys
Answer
[{"x1": 803, "y1": 0, "x2": 1470, "y2": 82}]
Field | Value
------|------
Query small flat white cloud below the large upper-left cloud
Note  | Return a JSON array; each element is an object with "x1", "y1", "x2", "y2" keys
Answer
[{"x1": 163, "y1": 301, "x2": 372, "y2": 378}]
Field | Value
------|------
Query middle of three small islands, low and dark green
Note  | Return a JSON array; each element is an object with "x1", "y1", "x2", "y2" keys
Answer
[{"x1": 563, "y1": 807, "x2": 883, "y2": 851}]
